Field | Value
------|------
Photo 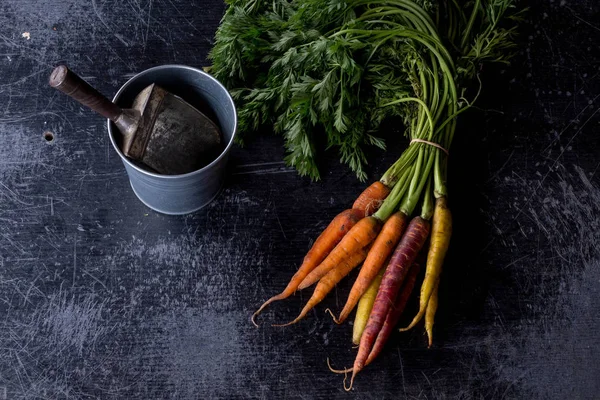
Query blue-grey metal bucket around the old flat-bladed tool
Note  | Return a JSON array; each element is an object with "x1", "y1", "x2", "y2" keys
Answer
[{"x1": 108, "y1": 65, "x2": 237, "y2": 214}]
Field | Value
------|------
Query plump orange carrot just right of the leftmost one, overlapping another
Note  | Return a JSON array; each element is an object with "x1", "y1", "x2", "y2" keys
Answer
[{"x1": 298, "y1": 217, "x2": 382, "y2": 289}]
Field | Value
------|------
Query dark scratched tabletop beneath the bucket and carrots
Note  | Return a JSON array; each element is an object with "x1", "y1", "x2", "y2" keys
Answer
[{"x1": 0, "y1": 0, "x2": 600, "y2": 399}]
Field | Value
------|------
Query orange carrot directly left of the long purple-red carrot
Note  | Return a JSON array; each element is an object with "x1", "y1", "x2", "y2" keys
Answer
[{"x1": 336, "y1": 211, "x2": 406, "y2": 324}]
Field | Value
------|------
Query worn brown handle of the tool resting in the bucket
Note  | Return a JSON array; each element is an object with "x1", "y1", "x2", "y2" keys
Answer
[{"x1": 49, "y1": 65, "x2": 123, "y2": 121}]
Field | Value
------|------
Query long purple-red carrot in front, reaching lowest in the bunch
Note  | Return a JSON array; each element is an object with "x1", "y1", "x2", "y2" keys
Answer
[{"x1": 345, "y1": 217, "x2": 430, "y2": 390}]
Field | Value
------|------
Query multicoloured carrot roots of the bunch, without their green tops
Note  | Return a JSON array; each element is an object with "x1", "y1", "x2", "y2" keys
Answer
[{"x1": 252, "y1": 177, "x2": 451, "y2": 388}]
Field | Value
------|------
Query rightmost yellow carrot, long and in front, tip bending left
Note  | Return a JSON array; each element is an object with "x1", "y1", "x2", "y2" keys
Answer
[{"x1": 400, "y1": 197, "x2": 452, "y2": 332}]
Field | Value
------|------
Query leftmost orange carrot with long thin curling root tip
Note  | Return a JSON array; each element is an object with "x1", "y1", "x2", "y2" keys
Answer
[{"x1": 252, "y1": 209, "x2": 364, "y2": 326}]
